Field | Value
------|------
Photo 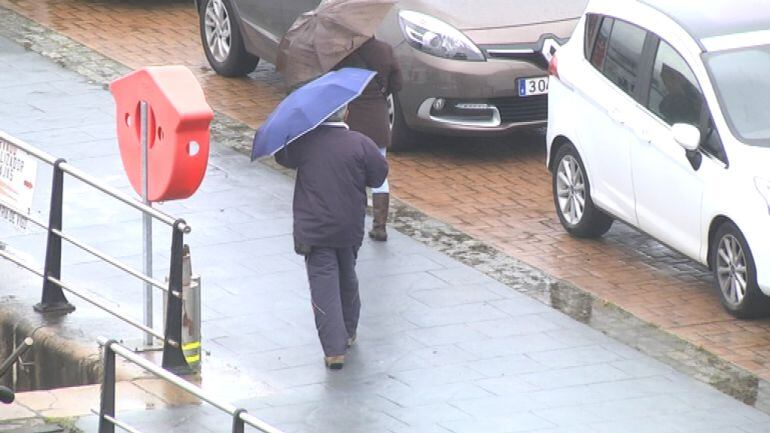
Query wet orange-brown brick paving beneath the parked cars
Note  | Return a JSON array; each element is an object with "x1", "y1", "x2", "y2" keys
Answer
[{"x1": 0, "y1": 0, "x2": 770, "y2": 398}]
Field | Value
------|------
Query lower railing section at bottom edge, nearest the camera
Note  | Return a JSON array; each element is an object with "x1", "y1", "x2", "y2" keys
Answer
[{"x1": 97, "y1": 337, "x2": 282, "y2": 433}]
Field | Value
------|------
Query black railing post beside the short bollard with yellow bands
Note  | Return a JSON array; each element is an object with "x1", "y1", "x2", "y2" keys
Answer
[{"x1": 162, "y1": 219, "x2": 193, "y2": 375}]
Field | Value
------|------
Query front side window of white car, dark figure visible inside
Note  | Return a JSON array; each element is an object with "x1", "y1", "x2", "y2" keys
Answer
[{"x1": 647, "y1": 41, "x2": 703, "y2": 126}]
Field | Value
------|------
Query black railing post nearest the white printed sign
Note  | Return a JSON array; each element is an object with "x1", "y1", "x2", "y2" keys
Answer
[{"x1": 34, "y1": 159, "x2": 75, "y2": 314}]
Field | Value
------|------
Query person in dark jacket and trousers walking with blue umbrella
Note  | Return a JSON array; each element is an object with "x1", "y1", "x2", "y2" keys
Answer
[{"x1": 252, "y1": 68, "x2": 388, "y2": 369}]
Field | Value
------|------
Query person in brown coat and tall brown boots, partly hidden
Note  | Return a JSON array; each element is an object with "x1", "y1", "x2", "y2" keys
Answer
[{"x1": 336, "y1": 37, "x2": 403, "y2": 241}]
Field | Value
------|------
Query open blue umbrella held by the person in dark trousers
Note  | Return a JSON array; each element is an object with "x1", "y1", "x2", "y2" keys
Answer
[{"x1": 251, "y1": 68, "x2": 376, "y2": 161}]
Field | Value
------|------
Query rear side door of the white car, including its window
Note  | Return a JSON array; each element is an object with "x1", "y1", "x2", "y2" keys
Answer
[{"x1": 575, "y1": 17, "x2": 647, "y2": 224}]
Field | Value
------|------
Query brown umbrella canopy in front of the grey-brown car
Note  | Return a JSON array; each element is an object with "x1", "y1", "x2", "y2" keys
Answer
[{"x1": 276, "y1": 0, "x2": 396, "y2": 86}]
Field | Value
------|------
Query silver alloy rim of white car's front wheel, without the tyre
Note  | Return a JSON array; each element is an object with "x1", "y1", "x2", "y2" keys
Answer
[{"x1": 716, "y1": 234, "x2": 748, "y2": 305}]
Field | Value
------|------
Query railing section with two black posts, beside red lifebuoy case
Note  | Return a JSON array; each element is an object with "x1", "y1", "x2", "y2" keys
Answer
[{"x1": 0, "y1": 131, "x2": 192, "y2": 373}]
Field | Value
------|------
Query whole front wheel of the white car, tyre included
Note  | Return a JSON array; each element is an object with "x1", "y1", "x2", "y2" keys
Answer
[{"x1": 709, "y1": 221, "x2": 770, "y2": 319}]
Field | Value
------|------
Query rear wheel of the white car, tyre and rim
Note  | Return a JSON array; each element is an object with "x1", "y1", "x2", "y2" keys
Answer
[{"x1": 553, "y1": 144, "x2": 612, "y2": 238}]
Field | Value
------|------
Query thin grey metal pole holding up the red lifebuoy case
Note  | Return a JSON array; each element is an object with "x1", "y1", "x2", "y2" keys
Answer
[{"x1": 140, "y1": 101, "x2": 153, "y2": 347}]
